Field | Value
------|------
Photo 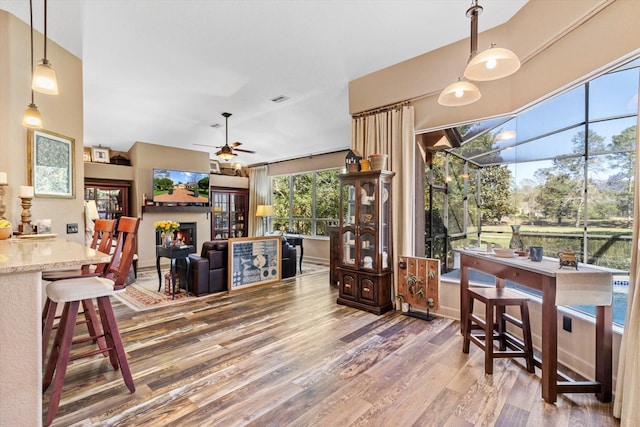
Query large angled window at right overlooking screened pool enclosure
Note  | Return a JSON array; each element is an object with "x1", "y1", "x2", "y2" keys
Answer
[{"x1": 425, "y1": 55, "x2": 640, "y2": 323}]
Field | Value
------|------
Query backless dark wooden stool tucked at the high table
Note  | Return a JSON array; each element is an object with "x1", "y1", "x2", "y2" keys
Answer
[{"x1": 462, "y1": 288, "x2": 535, "y2": 374}]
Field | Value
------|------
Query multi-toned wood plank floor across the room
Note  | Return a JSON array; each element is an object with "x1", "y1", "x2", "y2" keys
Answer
[{"x1": 43, "y1": 273, "x2": 619, "y2": 427}]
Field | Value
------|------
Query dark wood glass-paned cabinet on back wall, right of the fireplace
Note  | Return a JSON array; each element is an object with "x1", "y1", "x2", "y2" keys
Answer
[{"x1": 211, "y1": 187, "x2": 249, "y2": 240}]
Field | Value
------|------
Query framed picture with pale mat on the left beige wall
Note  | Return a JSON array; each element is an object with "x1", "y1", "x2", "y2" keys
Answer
[{"x1": 27, "y1": 129, "x2": 75, "y2": 198}]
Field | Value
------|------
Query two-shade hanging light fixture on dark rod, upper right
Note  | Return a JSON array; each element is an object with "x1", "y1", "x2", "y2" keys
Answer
[{"x1": 438, "y1": 0, "x2": 520, "y2": 107}]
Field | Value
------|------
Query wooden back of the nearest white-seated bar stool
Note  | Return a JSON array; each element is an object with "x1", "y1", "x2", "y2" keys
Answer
[{"x1": 104, "y1": 216, "x2": 140, "y2": 290}]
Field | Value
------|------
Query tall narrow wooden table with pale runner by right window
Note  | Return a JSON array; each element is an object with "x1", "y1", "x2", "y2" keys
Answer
[{"x1": 459, "y1": 250, "x2": 613, "y2": 403}]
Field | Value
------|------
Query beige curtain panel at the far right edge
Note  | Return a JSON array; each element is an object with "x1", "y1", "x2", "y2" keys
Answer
[{"x1": 613, "y1": 74, "x2": 640, "y2": 427}]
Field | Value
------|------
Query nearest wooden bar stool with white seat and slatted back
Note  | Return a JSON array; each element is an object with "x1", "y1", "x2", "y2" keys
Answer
[{"x1": 42, "y1": 217, "x2": 140, "y2": 425}]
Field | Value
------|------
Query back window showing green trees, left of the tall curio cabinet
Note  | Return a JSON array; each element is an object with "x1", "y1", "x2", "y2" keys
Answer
[{"x1": 271, "y1": 168, "x2": 341, "y2": 236}]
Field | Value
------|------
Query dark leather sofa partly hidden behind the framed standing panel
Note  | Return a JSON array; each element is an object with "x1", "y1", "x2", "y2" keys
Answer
[{"x1": 177, "y1": 237, "x2": 297, "y2": 296}]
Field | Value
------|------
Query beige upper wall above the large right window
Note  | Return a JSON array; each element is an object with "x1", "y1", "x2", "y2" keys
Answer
[{"x1": 349, "y1": 0, "x2": 640, "y2": 131}]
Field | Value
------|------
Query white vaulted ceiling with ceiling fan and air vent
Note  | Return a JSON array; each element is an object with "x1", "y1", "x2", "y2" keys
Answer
[{"x1": 0, "y1": 0, "x2": 526, "y2": 164}]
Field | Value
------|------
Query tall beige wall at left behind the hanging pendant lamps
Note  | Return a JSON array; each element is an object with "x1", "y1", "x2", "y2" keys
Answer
[{"x1": 0, "y1": 10, "x2": 84, "y2": 243}]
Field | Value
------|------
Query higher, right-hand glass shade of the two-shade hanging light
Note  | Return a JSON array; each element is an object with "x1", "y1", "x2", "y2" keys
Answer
[{"x1": 464, "y1": 46, "x2": 520, "y2": 82}]
